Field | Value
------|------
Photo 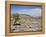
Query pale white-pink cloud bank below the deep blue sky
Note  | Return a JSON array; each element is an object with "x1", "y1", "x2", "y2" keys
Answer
[{"x1": 15, "y1": 8, "x2": 41, "y2": 17}]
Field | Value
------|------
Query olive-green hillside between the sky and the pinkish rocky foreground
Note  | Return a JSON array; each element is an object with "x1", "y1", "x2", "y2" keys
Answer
[{"x1": 12, "y1": 14, "x2": 41, "y2": 23}]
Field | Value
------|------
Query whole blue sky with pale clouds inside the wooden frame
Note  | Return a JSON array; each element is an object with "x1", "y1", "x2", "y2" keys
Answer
[{"x1": 11, "y1": 5, "x2": 41, "y2": 17}]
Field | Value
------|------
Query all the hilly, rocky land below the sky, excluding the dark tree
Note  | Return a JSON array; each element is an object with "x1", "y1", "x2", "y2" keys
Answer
[{"x1": 11, "y1": 15, "x2": 41, "y2": 32}]
